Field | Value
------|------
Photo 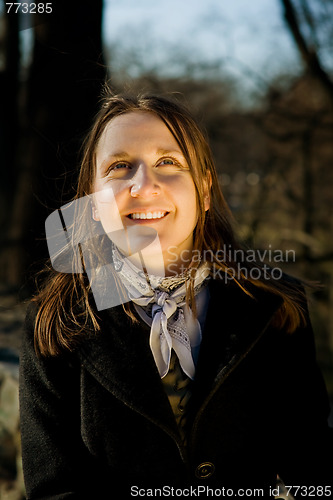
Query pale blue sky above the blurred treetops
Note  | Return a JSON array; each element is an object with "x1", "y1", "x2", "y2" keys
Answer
[{"x1": 103, "y1": 0, "x2": 300, "y2": 79}]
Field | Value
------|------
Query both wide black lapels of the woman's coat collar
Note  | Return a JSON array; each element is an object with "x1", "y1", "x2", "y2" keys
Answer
[{"x1": 78, "y1": 280, "x2": 281, "y2": 441}]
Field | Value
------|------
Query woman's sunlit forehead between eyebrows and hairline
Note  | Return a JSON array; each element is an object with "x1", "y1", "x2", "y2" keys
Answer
[{"x1": 96, "y1": 111, "x2": 180, "y2": 156}]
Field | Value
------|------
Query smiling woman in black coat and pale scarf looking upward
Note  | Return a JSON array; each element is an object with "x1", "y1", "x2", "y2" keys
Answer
[{"x1": 20, "y1": 94, "x2": 332, "y2": 499}]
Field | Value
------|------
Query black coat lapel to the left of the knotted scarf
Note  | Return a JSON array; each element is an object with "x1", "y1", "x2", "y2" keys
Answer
[{"x1": 79, "y1": 306, "x2": 179, "y2": 439}]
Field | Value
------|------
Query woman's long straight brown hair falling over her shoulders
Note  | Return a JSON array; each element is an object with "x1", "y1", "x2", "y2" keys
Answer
[{"x1": 34, "y1": 88, "x2": 304, "y2": 356}]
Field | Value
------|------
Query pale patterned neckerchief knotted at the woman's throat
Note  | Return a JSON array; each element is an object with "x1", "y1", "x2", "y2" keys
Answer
[{"x1": 113, "y1": 245, "x2": 209, "y2": 380}]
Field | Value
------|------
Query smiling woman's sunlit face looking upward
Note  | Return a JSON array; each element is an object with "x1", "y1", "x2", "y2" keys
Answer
[{"x1": 93, "y1": 111, "x2": 208, "y2": 274}]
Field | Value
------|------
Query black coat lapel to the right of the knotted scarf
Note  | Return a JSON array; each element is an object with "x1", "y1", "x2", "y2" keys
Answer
[{"x1": 193, "y1": 280, "x2": 282, "y2": 408}]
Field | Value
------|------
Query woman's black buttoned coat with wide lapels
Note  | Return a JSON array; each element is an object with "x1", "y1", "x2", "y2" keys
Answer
[{"x1": 20, "y1": 280, "x2": 333, "y2": 500}]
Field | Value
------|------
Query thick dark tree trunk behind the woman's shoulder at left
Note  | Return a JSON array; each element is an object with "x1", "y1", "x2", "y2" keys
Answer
[{"x1": 0, "y1": 0, "x2": 105, "y2": 285}]
